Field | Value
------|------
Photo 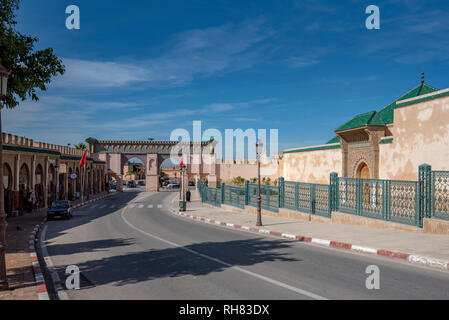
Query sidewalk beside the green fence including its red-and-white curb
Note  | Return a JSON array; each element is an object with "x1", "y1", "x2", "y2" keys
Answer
[{"x1": 176, "y1": 191, "x2": 449, "y2": 269}]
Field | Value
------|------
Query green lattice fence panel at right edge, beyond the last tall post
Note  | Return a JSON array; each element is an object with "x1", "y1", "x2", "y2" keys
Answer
[{"x1": 431, "y1": 171, "x2": 449, "y2": 220}]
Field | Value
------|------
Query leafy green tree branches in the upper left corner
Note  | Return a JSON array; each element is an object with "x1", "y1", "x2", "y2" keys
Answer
[{"x1": 0, "y1": 0, "x2": 65, "y2": 108}]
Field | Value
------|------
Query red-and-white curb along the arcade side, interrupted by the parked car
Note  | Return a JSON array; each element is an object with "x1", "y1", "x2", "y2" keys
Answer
[{"x1": 28, "y1": 193, "x2": 114, "y2": 300}]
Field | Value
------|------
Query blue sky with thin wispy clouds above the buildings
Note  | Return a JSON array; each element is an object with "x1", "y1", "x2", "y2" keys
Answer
[{"x1": 3, "y1": 0, "x2": 449, "y2": 158}]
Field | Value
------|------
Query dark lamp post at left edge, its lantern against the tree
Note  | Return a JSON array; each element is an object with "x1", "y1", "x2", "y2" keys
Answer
[{"x1": 0, "y1": 66, "x2": 9, "y2": 290}]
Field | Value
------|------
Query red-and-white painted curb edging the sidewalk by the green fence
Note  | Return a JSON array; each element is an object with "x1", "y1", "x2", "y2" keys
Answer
[{"x1": 171, "y1": 209, "x2": 449, "y2": 270}]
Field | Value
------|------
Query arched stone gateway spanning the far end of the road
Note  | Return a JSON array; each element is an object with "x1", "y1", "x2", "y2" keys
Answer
[{"x1": 86, "y1": 138, "x2": 217, "y2": 192}]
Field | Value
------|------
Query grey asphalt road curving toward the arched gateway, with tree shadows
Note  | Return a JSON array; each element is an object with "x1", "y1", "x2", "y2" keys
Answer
[{"x1": 45, "y1": 189, "x2": 449, "y2": 300}]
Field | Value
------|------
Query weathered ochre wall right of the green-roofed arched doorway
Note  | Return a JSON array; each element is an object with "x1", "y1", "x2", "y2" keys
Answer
[{"x1": 379, "y1": 97, "x2": 449, "y2": 180}]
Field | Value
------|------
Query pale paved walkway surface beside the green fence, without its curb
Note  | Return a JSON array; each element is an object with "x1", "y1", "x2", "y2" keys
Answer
[{"x1": 181, "y1": 191, "x2": 449, "y2": 260}]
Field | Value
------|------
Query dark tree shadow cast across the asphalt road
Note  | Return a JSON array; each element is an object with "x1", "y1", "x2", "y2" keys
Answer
[{"x1": 50, "y1": 238, "x2": 299, "y2": 289}]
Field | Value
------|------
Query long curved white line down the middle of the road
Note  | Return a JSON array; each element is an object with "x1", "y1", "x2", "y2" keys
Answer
[{"x1": 120, "y1": 208, "x2": 328, "y2": 300}]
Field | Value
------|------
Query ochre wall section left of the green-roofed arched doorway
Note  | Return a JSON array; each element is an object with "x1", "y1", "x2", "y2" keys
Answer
[{"x1": 282, "y1": 149, "x2": 342, "y2": 184}]
